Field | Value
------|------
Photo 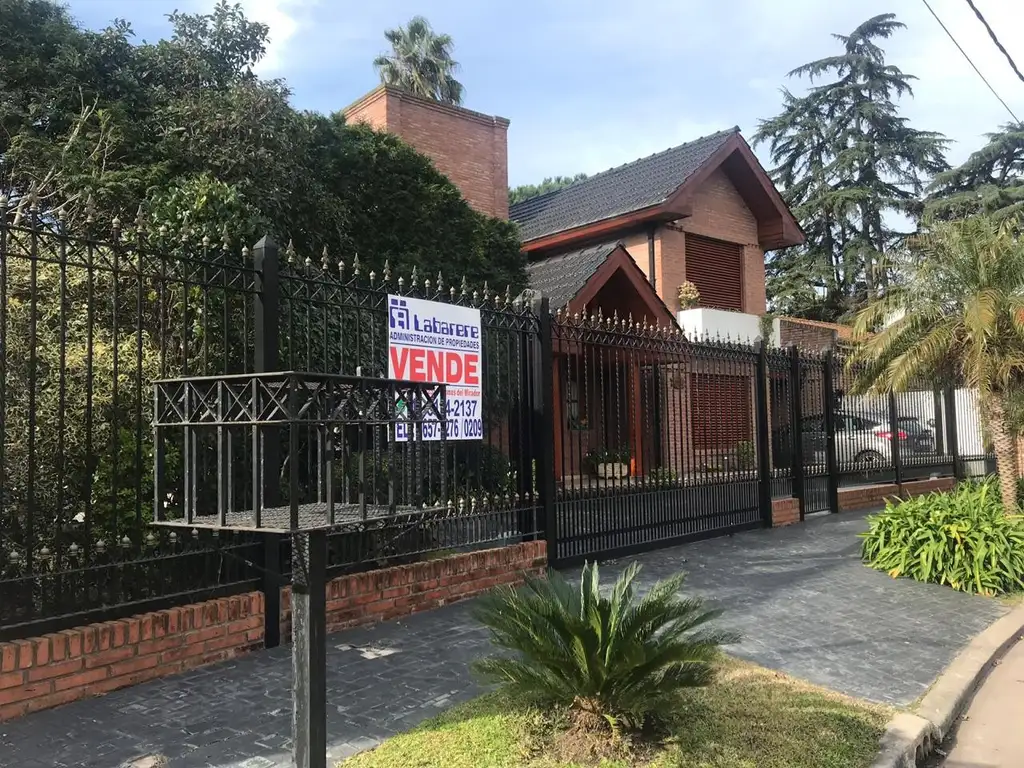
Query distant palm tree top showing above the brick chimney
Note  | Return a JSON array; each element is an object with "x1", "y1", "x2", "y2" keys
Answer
[{"x1": 374, "y1": 16, "x2": 463, "y2": 104}]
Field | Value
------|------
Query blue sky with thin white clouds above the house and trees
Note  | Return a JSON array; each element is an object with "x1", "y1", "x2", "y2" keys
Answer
[{"x1": 69, "y1": 0, "x2": 1024, "y2": 184}]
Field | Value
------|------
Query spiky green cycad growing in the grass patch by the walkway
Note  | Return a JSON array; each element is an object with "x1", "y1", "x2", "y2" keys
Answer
[{"x1": 474, "y1": 563, "x2": 736, "y2": 731}]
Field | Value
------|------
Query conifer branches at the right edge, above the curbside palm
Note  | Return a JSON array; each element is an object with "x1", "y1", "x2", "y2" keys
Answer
[{"x1": 926, "y1": 123, "x2": 1024, "y2": 218}]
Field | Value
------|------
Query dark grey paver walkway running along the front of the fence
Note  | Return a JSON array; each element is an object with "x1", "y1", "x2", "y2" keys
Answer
[{"x1": 0, "y1": 513, "x2": 1006, "y2": 768}]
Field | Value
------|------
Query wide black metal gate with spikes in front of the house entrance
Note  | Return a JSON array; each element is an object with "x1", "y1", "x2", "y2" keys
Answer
[{"x1": 549, "y1": 314, "x2": 763, "y2": 565}]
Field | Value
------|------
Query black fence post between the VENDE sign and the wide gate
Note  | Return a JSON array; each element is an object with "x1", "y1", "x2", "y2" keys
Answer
[{"x1": 532, "y1": 296, "x2": 558, "y2": 565}]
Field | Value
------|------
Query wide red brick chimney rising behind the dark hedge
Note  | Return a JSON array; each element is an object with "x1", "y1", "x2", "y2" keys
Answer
[{"x1": 342, "y1": 85, "x2": 509, "y2": 219}]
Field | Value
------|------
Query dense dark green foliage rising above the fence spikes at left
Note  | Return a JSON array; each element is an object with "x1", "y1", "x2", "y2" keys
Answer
[{"x1": 0, "y1": 0, "x2": 526, "y2": 293}]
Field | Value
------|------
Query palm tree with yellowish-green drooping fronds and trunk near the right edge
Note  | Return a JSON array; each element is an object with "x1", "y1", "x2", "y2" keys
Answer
[{"x1": 849, "y1": 216, "x2": 1024, "y2": 514}]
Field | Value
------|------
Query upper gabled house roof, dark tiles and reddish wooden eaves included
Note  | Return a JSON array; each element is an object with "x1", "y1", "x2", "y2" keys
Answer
[{"x1": 509, "y1": 127, "x2": 804, "y2": 252}]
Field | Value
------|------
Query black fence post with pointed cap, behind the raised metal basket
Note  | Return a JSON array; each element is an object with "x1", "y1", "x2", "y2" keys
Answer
[{"x1": 253, "y1": 237, "x2": 281, "y2": 648}]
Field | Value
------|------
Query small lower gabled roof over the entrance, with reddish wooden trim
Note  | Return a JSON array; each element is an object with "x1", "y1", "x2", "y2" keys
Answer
[{"x1": 526, "y1": 242, "x2": 676, "y2": 325}]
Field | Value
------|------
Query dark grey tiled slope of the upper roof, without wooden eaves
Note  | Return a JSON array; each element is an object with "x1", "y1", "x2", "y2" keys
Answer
[{"x1": 509, "y1": 127, "x2": 739, "y2": 242}]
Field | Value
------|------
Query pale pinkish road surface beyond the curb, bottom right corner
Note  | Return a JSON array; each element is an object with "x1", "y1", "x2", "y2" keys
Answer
[{"x1": 941, "y1": 640, "x2": 1024, "y2": 768}]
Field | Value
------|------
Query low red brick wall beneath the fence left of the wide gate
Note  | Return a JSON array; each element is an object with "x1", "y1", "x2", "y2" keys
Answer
[{"x1": 0, "y1": 542, "x2": 547, "y2": 722}]
